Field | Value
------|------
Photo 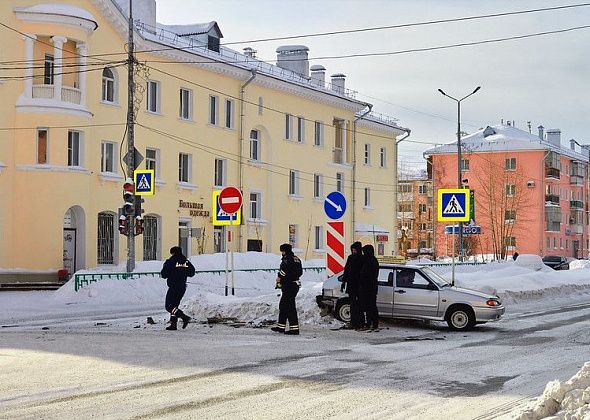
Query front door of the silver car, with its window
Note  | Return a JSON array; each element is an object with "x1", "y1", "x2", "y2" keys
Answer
[{"x1": 393, "y1": 267, "x2": 439, "y2": 317}]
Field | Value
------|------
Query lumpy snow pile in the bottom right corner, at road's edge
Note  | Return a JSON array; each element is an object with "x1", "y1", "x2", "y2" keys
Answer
[{"x1": 515, "y1": 362, "x2": 590, "y2": 420}]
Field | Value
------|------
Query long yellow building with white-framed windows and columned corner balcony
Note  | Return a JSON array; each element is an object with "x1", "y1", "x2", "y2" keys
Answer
[{"x1": 0, "y1": 0, "x2": 409, "y2": 278}]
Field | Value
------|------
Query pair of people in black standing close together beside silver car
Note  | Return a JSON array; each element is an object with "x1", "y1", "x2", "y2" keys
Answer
[{"x1": 340, "y1": 242, "x2": 379, "y2": 331}]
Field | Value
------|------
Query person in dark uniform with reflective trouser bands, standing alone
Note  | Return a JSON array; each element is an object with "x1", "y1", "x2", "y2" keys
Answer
[{"x1": 271, "y1": 244, "x2": 303, "y2": 335}]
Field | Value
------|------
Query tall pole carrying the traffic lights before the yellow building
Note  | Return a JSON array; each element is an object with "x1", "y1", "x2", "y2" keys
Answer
[{"x1": 126, "y1": 0, "x2": 141, "y2": 273}]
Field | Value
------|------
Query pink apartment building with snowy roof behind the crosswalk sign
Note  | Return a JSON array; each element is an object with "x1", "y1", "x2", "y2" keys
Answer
[{"x1": 424, "y1": 124, "x2": 590, "y2": 257}]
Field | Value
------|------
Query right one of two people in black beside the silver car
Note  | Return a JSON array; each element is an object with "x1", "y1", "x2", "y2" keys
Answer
[{"x1": 360, "y1": 245, "x2": 379, "y2": 331}]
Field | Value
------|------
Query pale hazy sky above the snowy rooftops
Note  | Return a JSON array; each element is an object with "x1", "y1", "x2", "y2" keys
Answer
[{"x1": 157, "y1": 0, "x2": 590, "y2": 167}]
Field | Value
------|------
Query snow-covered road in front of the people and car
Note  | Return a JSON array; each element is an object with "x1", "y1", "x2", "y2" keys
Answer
[{"x1": 0, "y1": 301, "x2": 590, "y2": 419}]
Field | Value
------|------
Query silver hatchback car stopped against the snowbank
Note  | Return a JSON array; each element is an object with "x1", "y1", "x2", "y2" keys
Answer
[{"x1": 316, "y1": 264, "x2": 505, "y2": 331}]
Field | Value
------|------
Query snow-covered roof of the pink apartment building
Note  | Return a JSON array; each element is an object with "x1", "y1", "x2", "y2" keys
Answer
[{"x1": 424, "y1": 124, "x2": 588, "y2": 162}]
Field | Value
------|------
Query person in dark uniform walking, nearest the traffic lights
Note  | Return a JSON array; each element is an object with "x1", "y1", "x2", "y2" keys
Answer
[{"x1": 160, "y1": 246, "x2": 195, "y2": 330}]
